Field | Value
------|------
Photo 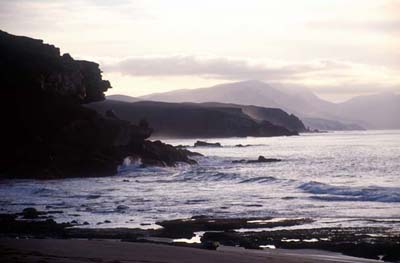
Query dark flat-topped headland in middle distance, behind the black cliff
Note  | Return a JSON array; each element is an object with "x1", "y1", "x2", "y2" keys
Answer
[{"x1": 87, "y1": 100, "x2": 304, "y2": 138}]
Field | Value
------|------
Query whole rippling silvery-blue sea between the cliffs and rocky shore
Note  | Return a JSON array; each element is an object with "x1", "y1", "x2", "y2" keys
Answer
[{"x1": 0, "y1": 131, "x2": 400, "y2": 229}]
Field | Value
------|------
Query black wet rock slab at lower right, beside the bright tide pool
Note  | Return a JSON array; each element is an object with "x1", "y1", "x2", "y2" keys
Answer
[{"x1": 201, "y1": 227, "x2": 400, "y2": 262}]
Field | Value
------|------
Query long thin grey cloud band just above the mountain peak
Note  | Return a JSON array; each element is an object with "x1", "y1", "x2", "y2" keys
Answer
[{"x1": 103, "y1": 56, "x2": 348, "y2": 80}]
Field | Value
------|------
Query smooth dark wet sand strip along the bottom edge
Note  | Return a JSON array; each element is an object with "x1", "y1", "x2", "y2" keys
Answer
[{"x1": 0, "y1": 238, "x2": 381, "y2": 263}]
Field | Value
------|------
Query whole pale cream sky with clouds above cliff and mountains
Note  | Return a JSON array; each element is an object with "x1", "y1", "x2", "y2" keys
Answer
[{"x1": 0, "y1": 0, "x2": 400, "y2": 101}]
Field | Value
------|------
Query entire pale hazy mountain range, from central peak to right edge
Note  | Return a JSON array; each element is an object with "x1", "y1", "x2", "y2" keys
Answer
[{"x1": 139, "y1": 80, "x2": 400, "y2": 130}]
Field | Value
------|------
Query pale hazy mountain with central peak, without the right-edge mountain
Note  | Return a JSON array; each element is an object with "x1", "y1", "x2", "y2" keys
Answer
[{"x1": 140, "y1": 80, "x2": 333, "y2": 120}]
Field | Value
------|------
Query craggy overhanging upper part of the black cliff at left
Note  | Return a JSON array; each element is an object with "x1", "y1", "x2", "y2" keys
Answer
[{"x1": 0, "y1": 31, "x2": 111, "y2": 102}]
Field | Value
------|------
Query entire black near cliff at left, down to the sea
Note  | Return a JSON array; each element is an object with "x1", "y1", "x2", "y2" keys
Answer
[{"x1": 0, "y1": 31, "x2": 194, "y2": 178}]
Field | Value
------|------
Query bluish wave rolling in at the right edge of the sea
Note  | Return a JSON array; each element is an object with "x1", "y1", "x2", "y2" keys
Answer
[{"x1": 299, "y1": 181, "x2": 400, "y2": 203}]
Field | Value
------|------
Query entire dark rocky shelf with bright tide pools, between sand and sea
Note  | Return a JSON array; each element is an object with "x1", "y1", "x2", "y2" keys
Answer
[{"x1": 0, "y1": 209, "x2": 400, "y2": 262}]
